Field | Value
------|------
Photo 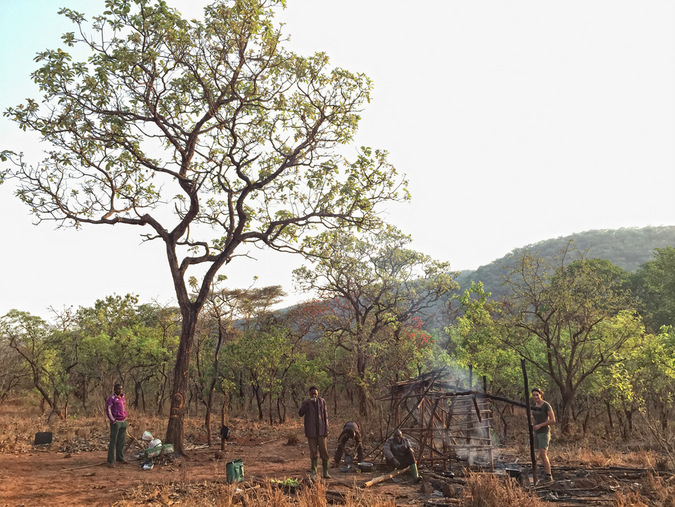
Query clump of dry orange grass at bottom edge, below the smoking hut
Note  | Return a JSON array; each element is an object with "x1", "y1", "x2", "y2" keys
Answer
[{"x1": 462, "y1": 473, "x2": 545, "y2": 507}]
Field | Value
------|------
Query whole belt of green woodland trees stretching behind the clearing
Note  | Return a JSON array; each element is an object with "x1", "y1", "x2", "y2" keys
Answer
[{"x1": 0, "y1": 236, "x2": 675, "y2": 446}]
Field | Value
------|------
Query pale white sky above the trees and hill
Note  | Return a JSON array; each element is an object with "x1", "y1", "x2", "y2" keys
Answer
[{"x1": 0, "y1": 0, "x2": 675, "y2": 316}]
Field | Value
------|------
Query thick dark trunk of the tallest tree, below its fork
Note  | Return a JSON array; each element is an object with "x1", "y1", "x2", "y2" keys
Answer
[{"x1": 164, "y1": 306, "x2": 199, "y2": 456}]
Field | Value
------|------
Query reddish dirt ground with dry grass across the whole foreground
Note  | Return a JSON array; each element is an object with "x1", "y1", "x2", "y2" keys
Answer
[{"x1": 0, "y1": 404, "x2": 675, "y2": 507}]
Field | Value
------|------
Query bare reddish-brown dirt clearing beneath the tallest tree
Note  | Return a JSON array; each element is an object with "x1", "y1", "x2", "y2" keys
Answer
[{"x1": 0, "y1": 438, "x2": 428, "y2": 507}]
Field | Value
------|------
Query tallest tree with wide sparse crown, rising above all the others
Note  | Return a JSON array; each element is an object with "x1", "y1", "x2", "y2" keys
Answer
[{"x1": 2, "y1": 0, "x2": 407, "y2": 452}]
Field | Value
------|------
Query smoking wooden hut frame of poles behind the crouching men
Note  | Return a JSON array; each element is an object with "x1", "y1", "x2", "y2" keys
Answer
[{"x1": 389, "y1": 370, "x2": 494, "y2": 470}]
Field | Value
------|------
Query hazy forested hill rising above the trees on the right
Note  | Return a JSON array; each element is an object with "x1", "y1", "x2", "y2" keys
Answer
[{"x1": 457, "y1": 226, "x2": 675, "y2": 297}]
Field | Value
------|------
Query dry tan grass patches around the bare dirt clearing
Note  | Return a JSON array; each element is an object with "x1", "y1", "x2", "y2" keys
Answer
[{"x1": 5, "y1": 402, "x2": 675, "y2": 507}]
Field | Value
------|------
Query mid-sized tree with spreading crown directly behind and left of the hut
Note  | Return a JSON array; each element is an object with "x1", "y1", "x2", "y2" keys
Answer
[{"x1": 294, "y1": 226, "x2": 456, "y2": 416}]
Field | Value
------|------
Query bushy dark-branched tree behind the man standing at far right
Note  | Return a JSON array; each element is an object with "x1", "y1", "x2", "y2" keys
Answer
[{"x1": 496, "y1": 244, "x2": 642, "y2": 433}]
